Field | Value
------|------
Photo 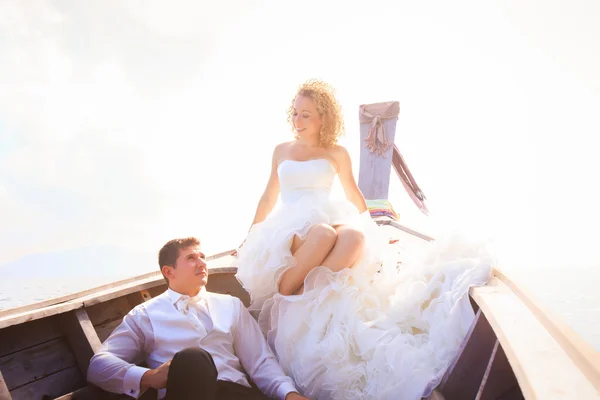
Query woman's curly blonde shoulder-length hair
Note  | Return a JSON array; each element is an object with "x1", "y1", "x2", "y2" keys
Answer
[{"x1": 287, "y1": 79, "x2": 344, "y2": 147}]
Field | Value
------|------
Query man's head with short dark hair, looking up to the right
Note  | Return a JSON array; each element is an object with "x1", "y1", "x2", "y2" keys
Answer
[{"x1": 158, "y1": 237, "x2": 208, "y2": 295}]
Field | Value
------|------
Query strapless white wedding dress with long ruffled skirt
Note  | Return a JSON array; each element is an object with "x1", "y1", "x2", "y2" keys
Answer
[{"x1": 236, "y1": 159, "x2": 493, "y2": 400}]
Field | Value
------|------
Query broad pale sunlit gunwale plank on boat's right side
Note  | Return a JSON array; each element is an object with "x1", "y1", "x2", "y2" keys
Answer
[{"x1": 471, "y1": 277, "x2": 600, "y2": 400}]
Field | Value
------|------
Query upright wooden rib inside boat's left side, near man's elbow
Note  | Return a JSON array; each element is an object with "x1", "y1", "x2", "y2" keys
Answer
[{"x1": 62, "y1": 309, "x2": 101, "y2": 376}]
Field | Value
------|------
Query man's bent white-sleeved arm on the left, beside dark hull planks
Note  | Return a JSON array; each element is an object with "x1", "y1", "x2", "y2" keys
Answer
[{"x1": 87, "y1": 307, "x2": 153, "y2": 399}]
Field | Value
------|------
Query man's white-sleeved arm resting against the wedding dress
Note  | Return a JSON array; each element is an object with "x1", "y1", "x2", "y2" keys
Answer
[{"x1": 232, "y1": 297, "x2": 302, "y2": 400}]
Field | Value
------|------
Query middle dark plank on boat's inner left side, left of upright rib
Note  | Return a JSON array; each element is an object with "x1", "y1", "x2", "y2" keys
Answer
[{"x1": 0, "y1": 338, "x2": 76, "y2": 391}]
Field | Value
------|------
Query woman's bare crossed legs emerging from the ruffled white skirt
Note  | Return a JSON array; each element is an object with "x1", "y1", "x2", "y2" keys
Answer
[{"x1": 279, "y1": 224, "x2": 364, "y2": 295}]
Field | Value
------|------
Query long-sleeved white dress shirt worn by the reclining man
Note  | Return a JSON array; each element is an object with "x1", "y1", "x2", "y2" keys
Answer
[{"x1": 88, "y1": 288, "x2": 297, "y2": 399}]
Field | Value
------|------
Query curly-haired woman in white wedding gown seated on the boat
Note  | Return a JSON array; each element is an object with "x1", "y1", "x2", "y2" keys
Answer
[{"x1": 236, "y1": 81, "x2": 492, "y2": 400}]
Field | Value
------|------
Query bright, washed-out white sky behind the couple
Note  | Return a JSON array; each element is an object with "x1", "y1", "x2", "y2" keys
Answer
[{"x1": 0, "y1": 0, "x2": 600, "y2": 286}]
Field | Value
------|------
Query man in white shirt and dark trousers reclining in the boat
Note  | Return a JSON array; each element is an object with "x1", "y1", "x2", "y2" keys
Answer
[{"x1": 88, "y1": 237, "x2": 307, "y2": 400}]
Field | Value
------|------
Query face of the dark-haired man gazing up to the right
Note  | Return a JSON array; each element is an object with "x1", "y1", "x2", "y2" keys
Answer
[{"x1": 168, "y1": 246, "x2": 208, "y2": 289}]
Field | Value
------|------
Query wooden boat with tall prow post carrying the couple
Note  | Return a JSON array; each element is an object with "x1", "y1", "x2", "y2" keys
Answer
[{"x1": 0, "y1": 103, "x2": 600, "y2": 400}]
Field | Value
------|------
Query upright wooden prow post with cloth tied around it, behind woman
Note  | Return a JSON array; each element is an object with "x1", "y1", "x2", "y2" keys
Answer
[{"x1": 358, "y1": 101, "x2": 400, "y2": 200}]
